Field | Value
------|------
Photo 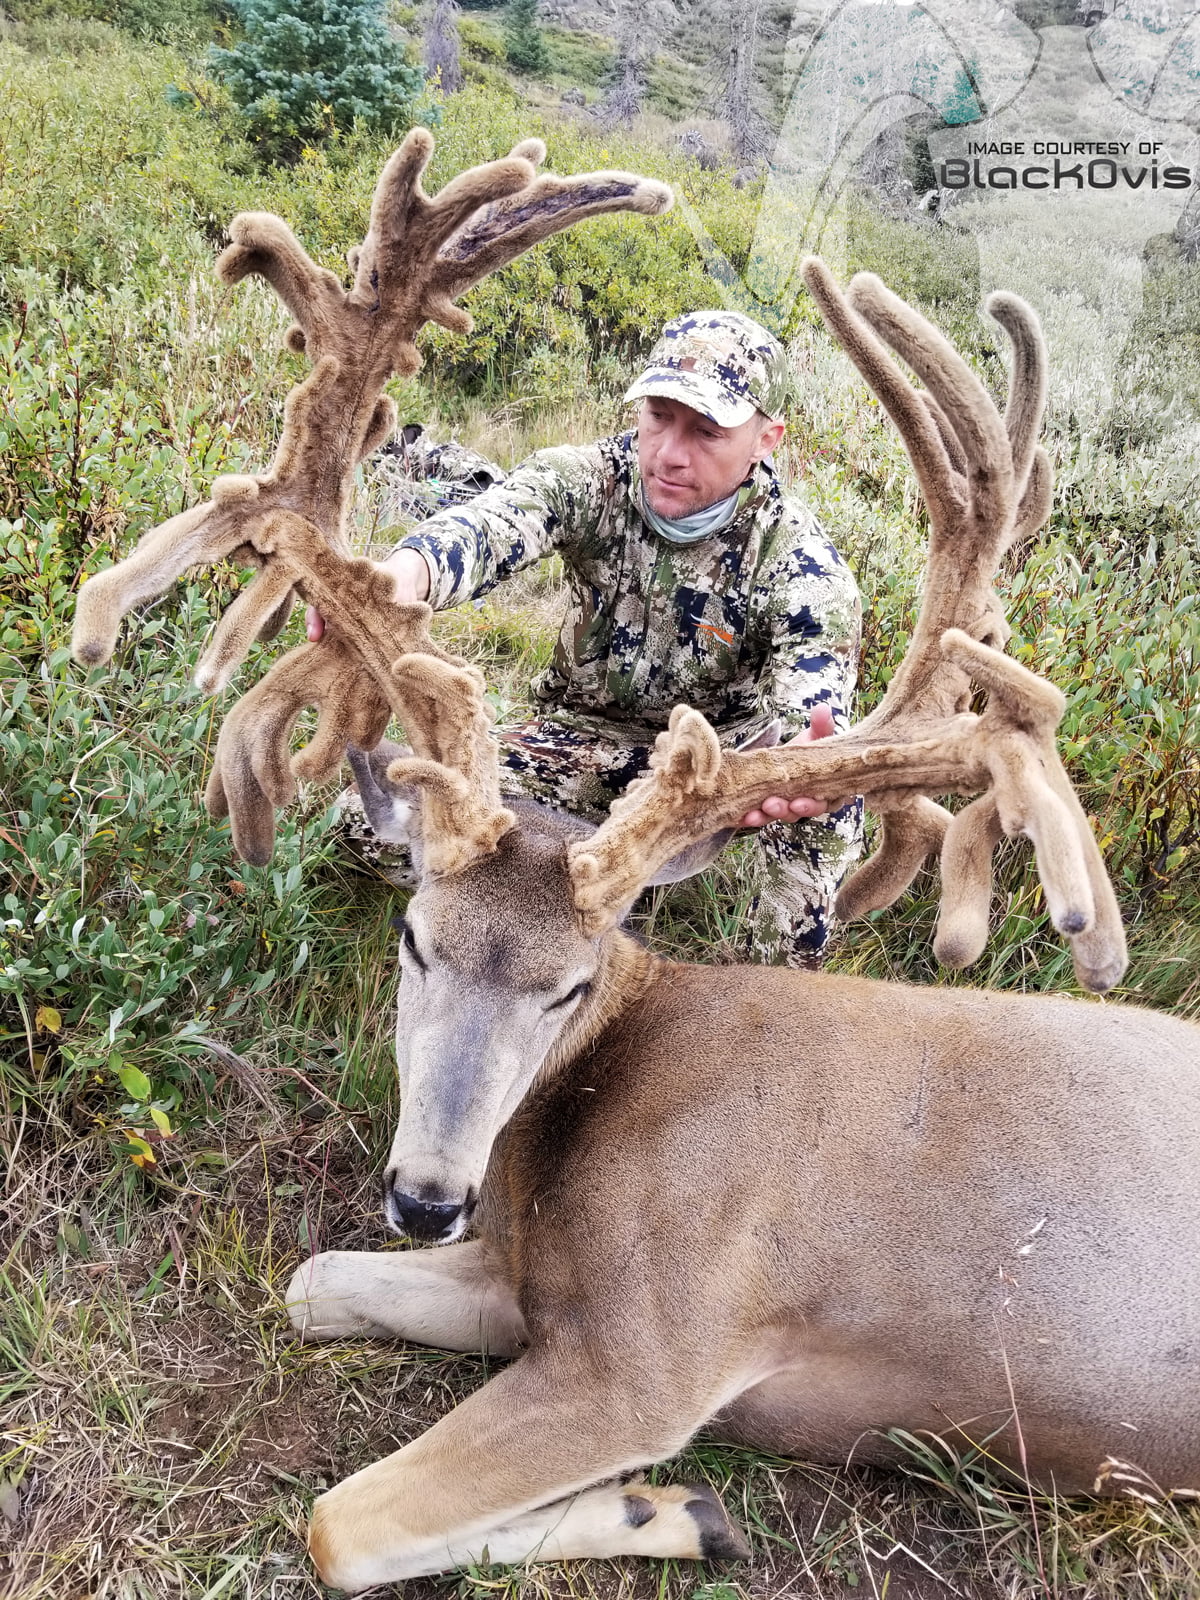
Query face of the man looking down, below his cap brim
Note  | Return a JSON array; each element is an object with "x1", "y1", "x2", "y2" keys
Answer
[{"x1": 637, "y1": 395, "x2": 784, "y2": 520}]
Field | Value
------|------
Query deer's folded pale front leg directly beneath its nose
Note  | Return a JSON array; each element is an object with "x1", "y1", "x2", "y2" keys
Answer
[{"x1": 286, "y1": 1240, "x2": 525, "y2": 1355}]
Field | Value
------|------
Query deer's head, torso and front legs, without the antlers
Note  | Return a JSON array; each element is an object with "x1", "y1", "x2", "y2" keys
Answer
[{"x1": 288, "y1": 819, "x2": 1200, "y2": 1589}]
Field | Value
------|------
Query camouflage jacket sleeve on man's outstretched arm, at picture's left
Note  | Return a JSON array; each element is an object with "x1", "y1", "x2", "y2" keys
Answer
[{"x1": 397, "y1": 445, "x2": 610, "y2": 611}]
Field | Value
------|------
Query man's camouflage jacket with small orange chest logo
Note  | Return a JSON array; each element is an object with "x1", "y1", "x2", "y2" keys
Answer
[{"x1": 402, "y1": 434, "x2": 861, "y2": 744}]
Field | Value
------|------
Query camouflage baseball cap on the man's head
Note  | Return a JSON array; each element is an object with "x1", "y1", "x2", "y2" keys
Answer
[{"x1": 626, "y1": 310, "x2": 790, "y2": 427}]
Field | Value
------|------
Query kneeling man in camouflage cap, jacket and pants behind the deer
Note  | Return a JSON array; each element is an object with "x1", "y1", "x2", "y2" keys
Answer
[{"x1": 310, "y1": 312, "x2": 861, "y2": 966}]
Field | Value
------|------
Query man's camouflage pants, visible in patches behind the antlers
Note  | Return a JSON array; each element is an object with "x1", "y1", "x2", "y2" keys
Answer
[{"x1": 342, "y1": 718, "x2": 862, "y2": 968}]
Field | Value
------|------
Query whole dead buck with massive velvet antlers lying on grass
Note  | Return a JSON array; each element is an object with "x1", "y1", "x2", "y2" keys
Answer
[{"x1": 68, "y1": 136, "x2": 1200, "y2": 1589}]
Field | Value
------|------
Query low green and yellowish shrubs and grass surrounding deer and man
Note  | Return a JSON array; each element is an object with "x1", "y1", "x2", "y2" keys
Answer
[{"x1": 0, "y1": 12, "x2": 1200, "y2": 1600}]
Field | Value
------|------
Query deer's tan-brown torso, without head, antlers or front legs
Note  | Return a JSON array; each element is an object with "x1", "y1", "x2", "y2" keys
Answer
[{"x1": 505, "y1": 963, "x2": 1200, "y2": 1491}]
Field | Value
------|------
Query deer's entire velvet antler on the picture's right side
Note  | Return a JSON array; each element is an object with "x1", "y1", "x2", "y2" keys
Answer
[{"x1": 571, "y1": 258, "x2": 1125, "y2": 990}]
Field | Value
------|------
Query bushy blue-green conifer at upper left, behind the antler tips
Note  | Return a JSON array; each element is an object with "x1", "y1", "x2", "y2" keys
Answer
[{"x1": 210, "y1": 0, "x2": 424, "y2": 157}]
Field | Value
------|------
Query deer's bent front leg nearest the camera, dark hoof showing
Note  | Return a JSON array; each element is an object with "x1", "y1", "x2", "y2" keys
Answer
[{"x1": 309, "y1": 1350, "x2": 749, "y2": 1592}]
